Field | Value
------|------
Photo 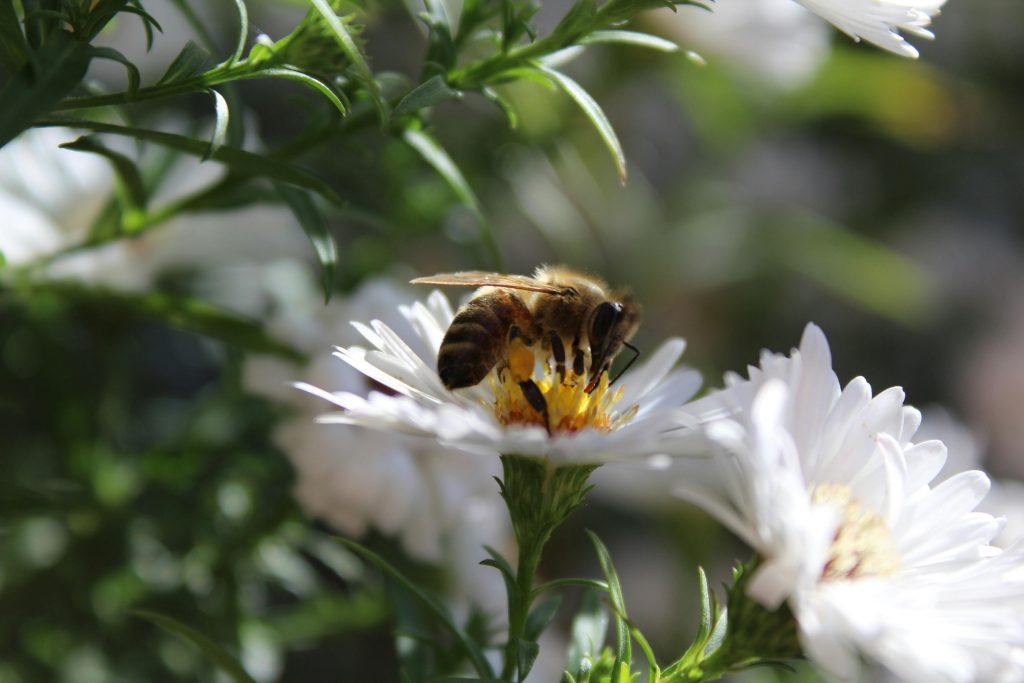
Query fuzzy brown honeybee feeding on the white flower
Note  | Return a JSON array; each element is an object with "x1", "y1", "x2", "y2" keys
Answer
[{"x1": 412, "y1": 265, "x2": 640, "y2": 395}]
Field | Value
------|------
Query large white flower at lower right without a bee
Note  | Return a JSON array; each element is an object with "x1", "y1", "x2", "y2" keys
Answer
[{"x1": 677, "y1": 326, "x2": 1024, "y2": 683}]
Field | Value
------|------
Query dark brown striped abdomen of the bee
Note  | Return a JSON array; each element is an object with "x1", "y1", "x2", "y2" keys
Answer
[{"x1": 437, "y1": 290, "x2": 529, "y2": 389}]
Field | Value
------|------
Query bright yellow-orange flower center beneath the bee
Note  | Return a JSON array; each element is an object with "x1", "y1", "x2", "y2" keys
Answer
[{"x1": 487, "y1": 339, "x2": 639, "y2": 434}]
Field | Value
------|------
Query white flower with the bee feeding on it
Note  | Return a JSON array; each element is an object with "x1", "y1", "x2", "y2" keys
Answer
[{"x1": 298, "y1": 292, "x2": 700, "y2": 465}]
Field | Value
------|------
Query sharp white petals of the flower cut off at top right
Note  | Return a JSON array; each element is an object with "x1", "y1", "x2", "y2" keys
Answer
[{"x1": 796, "y1": 0, "x2": 946, "y2": 57}]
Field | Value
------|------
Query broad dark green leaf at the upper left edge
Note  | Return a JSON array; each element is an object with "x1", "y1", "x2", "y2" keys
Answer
[{"x1": 0, "y1": 31, "x2": 92, "y2": 146}]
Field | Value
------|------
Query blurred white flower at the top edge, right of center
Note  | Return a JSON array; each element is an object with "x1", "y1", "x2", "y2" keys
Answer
[{"x1": 650, "y1": 0, "x2": 829, "y2": 88}]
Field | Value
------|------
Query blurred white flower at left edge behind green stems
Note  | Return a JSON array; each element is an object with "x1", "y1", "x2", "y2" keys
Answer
[{"x1": 0, "y1": 128, "x2": 311, "y2": 315}]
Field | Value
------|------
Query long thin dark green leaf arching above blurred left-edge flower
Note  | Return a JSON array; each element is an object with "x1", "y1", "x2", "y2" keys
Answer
[{"x1": 36, "y1": 117, "x2": 344, "y2": 206}]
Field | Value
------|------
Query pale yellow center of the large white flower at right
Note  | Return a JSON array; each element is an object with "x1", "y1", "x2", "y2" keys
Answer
[{"x1": 812, "y1": 483, "x2": 900, "y2": 581}]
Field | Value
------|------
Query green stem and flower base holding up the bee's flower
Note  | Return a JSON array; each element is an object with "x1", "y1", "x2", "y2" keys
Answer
[{"x1": 501, "y1": 456, "x2": 597, "y2": 681}]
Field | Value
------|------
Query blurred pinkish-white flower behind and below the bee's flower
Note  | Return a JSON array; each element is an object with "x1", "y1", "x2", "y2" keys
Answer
[{"x1": 245, "y1": 280, "x2": 513, "y2": 613}]
